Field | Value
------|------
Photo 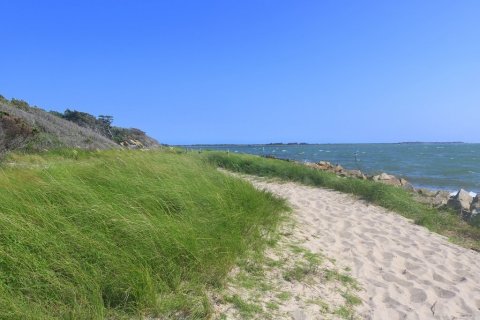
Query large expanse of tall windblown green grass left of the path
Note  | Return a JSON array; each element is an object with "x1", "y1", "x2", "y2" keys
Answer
[{"x1": 0, "y1": 150, "x2": 285, "y2": 319}]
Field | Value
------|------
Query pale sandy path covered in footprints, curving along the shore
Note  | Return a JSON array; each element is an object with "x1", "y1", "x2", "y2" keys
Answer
[{"x1": 248, "y1": 179, "x2": 480, "y2": 320}]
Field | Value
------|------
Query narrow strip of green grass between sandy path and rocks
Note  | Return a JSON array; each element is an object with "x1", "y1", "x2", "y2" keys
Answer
[{"x1": 203, "y1": 152, "x2": 480, "y2": 251}]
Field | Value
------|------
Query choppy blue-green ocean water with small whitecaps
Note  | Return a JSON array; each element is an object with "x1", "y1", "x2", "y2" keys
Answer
[{"x1": 184, "y1": 143, "x2": 480, "y2": 192}]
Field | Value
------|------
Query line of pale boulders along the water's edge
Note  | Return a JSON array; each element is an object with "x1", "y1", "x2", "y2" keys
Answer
[{"x1": 294, "y1": 161, "x2": 480, "y2": 225}]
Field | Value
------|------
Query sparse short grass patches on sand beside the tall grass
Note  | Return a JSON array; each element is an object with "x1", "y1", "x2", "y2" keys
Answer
[{"x1": 213, "y1": 219, "x2": 361, "y2": 320}]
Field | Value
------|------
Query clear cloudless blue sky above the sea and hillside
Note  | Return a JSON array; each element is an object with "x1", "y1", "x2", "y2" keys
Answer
[{"x1": 0, "y1": 0, "x2": 480, "y2": 144}]
